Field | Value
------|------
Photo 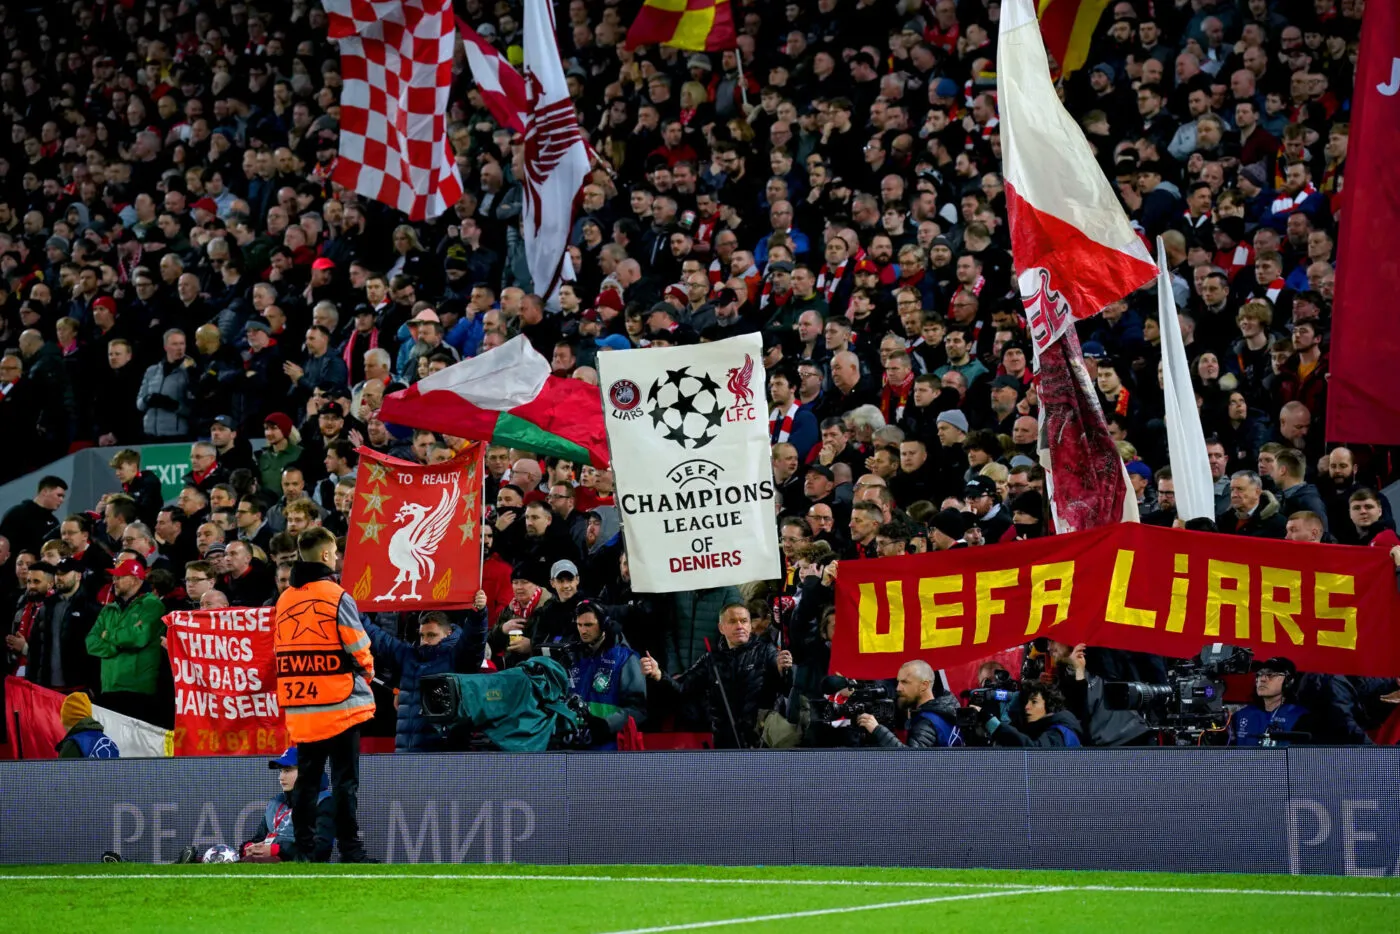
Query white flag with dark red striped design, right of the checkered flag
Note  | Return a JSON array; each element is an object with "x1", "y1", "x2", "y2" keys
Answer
[{"x1": 522, "y1": 0, "x2": 589, "y2": 307}]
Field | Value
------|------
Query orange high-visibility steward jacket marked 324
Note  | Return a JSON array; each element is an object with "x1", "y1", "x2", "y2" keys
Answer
[{"x1": 274, "y1": 580, "x2": 374, "y2": 742}]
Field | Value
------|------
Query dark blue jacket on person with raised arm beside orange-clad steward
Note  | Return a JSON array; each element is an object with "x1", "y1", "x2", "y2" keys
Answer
[{"x1": 361, "y1": 611, "x2": 486, "y2": 752}]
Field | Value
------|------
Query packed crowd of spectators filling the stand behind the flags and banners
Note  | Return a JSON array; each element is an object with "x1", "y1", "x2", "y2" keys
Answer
[{"x1": 0, "y1": 0, "x2": 1400, "y2": 751}]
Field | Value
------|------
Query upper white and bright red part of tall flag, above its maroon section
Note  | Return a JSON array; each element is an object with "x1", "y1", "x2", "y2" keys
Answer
[{"x1": 997, "y1": 0, "x2": 1156, "y2": 356}]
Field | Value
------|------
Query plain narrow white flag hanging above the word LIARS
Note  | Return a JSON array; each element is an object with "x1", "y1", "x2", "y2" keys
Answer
[{"x1": 1156, "y1": 237, "x2": 1215, "y2": 520}]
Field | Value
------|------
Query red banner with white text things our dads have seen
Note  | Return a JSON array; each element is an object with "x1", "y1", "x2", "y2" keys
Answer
[{"x1": 165, "y1": 606, "x2": 287, "y2": 756}]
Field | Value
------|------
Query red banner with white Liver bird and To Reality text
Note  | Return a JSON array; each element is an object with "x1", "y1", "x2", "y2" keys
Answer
[{"x1": 340, "y1": 444, "x2": 486, "y2": 612}]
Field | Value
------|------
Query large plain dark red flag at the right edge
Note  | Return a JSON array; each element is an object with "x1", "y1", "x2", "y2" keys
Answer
[{"x1": 1327, "y1": 3, "x2": 1400, "y2": 444}]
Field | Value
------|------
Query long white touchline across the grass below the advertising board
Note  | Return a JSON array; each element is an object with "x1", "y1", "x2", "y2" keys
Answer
[{"x1": 0, "y1": 870, "x2": 1400, "y2": 899}]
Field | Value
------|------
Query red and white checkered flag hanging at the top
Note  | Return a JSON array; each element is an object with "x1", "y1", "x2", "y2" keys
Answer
[{"x1": 323, "y1": 0, "x2": 462, "y2": 220}]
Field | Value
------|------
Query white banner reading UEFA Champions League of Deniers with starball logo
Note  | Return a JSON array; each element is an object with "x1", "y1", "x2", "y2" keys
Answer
[{"x1": 598, "y1": 335, "x2": 780, "y2": 594}]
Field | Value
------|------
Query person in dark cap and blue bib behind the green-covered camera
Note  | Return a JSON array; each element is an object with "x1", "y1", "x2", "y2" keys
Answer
[{"x1": 568, "y1": 601, "x2": 647, "y2": 749}]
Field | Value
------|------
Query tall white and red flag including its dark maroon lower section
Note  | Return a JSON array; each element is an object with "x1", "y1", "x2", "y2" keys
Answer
[{"x1": 997, "y1": 0, "x2": 1156, "y2": 531}]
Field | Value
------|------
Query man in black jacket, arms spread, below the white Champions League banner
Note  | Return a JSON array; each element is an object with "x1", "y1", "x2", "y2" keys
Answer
[{"x1": 641, "y1": 604, "x2": 792, "y2": 749}]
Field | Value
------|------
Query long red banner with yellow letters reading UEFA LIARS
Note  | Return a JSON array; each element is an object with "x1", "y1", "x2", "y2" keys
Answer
[{"x1": 832, "y1": 522, "x2": 1400, "y2": 678}]
